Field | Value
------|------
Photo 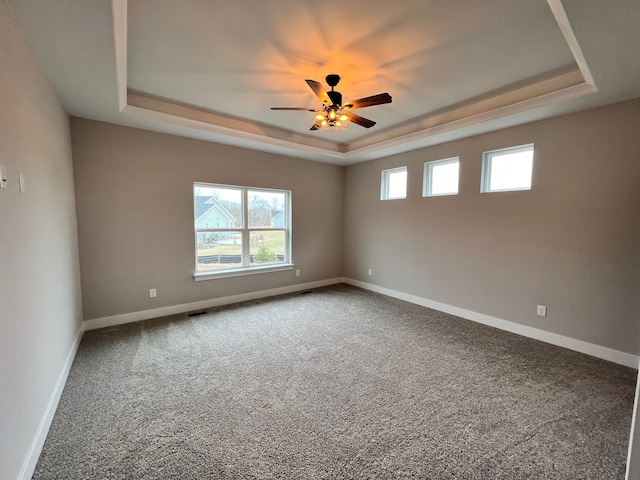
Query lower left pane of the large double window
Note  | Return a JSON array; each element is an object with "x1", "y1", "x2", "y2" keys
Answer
[{"x1": 196, "y1": 231, "x2": 242, "y2": 272}]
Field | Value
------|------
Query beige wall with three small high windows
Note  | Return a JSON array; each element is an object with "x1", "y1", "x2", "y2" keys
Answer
[{"x1": 344, "y1": 100, "x2": 640, "y2": 355}]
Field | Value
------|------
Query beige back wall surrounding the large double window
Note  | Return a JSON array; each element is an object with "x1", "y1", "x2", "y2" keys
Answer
[{"x1": 71, "y1": 118, "x2": 344, "y2": 320}]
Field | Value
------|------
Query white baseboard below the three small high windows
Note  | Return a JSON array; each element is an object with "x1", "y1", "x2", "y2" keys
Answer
[{"x1": 342, "y1": 278, "x2": 640, "y2": 370}]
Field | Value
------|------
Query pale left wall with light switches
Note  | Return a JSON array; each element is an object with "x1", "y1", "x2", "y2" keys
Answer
[{"x1": 0, "y1": 1, "x2": 82, "y2": 479}]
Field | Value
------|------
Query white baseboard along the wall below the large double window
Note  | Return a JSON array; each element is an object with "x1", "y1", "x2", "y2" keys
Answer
[{"x1": 84, "y1": 277, "x2": 343, "y2": 330}]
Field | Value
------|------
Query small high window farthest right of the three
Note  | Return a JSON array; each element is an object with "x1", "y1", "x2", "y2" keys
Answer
[{"x1": 480, "y1": 144, "x2": 533, "y2": 192}]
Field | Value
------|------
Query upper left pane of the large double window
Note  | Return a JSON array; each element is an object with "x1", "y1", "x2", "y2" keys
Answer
[{"x1": 194, "y1": 185, "x2": 242, "y2": 229}]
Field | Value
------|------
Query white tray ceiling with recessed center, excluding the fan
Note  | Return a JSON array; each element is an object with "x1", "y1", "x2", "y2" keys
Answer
[{"x1": 9, "y1": 0, "x2": 640, "y2": 165}]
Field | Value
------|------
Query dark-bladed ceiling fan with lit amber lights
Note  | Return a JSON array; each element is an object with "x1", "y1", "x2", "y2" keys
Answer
[{"x1": 271, "y1": 73, "x2": 391, "y2": 130}]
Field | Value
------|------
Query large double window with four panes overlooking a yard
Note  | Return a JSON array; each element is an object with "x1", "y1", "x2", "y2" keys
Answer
[{"x1": 193, "y1": 183, "x2": 292, "y2": 280}]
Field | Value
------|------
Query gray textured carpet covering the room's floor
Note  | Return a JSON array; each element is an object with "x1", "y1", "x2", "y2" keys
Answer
[{"x1": 33, "y1": 285, "x2": 636, "y2": 480}]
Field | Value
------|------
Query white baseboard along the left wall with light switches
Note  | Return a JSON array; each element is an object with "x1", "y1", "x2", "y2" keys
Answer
[{"x1": 18, "y1": 325, "x2": 84, "y2": 480}]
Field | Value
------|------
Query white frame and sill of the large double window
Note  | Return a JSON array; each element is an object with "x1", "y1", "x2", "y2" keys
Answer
[{"x1": 192, "y1": 182, "x2": 294, "y2": 282}]
